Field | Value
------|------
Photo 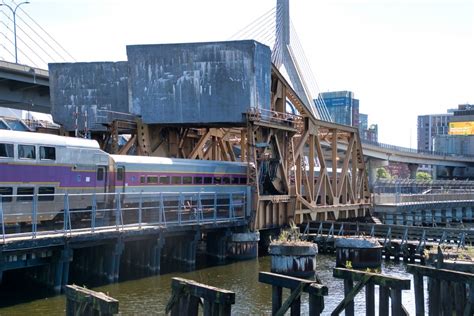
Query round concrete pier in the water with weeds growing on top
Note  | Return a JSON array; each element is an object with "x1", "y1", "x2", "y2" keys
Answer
[{"x1": 268, "y1": 242, "x2": 318, "y2": 278}]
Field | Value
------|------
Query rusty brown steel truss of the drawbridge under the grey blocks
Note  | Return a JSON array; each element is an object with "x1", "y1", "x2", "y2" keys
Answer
[{"x1": 103, "y1": 67, "x2": 370, "y2": 229}]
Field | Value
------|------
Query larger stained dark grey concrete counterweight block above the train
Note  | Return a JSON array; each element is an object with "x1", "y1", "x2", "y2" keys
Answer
[{"x1": 127, "y1": 40, "x2": 271, "y2": 125}]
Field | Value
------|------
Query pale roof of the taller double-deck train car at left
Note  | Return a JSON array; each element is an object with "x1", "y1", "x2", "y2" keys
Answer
[{"x1": 0, "y1": 130, "x2": 100, "y2": 149}]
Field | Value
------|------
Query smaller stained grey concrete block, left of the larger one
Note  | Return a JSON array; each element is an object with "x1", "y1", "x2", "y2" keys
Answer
[{"x1": 49, "y1": 62, "x2": 129, "y2": 131}]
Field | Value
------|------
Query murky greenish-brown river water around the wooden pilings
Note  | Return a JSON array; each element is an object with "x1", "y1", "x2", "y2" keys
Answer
[{"x1": 0, "y1": 255, "x2": 415, "y2": 315}]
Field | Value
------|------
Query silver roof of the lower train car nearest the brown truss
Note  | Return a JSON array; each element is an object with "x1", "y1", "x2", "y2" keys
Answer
[{"x1": 110, "y1": 155, "x2": 247, "y2": 167}]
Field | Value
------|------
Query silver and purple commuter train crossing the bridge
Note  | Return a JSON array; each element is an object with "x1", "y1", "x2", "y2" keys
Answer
[{"x1": 0, "y1": 130, "x2": 247, "y2": 224}]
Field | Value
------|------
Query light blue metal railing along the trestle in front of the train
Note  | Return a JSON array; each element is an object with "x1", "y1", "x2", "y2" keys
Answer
[{"x1": 0, "y1": 189, "x2": 250, "y2": 241}]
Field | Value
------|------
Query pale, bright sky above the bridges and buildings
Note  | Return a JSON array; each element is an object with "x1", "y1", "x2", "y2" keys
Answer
[{"x1": 0, "y1": 0, "x2": 474, "y2": 148}]
